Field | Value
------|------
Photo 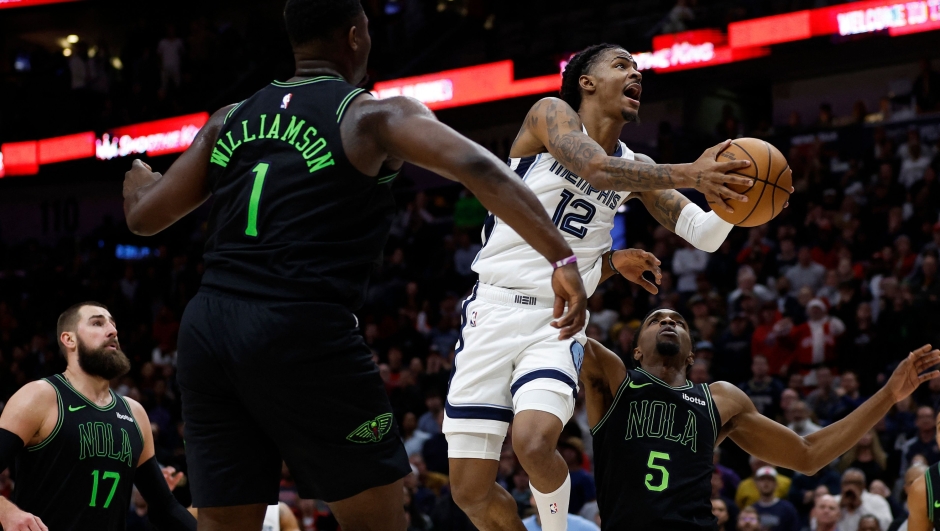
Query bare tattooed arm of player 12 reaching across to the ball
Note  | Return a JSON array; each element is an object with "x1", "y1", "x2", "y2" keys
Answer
[{"x1": 511, "y1": 98, "x2": 750, "y2": 211}]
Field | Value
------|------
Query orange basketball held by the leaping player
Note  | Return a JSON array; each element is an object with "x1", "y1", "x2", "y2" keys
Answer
[{"x1": 715, "y1": 138, "x2": 793, "y2": 227}]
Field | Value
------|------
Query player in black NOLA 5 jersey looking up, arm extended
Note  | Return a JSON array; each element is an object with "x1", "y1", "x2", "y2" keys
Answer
[{"x1": 581, "y1": 309, "x2": 940, "y2": 531}]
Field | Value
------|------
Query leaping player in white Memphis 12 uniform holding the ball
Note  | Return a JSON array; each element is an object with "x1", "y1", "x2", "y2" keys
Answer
[{"x1": 443, "y1": 45, "x2": 751, "y2": 531}]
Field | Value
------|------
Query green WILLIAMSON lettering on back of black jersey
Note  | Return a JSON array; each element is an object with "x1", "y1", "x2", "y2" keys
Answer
[{"x1": 210, "y1": 113, "x2": 336, "y2": 173}]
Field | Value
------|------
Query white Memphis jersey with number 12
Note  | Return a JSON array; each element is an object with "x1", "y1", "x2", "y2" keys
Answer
[{"x1": 473, "y1": 141, "x2": 635, "y2": 303}]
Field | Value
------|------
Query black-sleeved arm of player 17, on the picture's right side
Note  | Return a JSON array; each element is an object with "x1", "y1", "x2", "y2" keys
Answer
[{"x1": 126, "y1": 398, "x2": 196, "y2": 531}]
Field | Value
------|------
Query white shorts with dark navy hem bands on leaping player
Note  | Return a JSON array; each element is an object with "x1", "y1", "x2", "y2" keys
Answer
[{"x1": 443, "y1": 283, "x2": 587, "y2": 442}]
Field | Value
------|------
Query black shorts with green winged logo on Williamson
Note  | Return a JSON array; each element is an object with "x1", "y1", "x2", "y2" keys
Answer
[{"x1": 177, "y1": 288, "x2": 411, "y2": 507}]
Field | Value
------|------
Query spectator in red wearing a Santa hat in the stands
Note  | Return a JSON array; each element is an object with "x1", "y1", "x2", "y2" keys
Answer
[{"x1": 789, "y1": 299, "x2": 845, "y2": 384}]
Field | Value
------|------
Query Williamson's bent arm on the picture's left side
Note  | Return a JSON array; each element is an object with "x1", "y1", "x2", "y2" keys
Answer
[{"x1": 124, "y1": 105, "x2": 232, "y2": 236}]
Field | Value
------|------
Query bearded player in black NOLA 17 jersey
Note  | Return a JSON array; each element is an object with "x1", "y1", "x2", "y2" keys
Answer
[{"x1": 0, "y1": 302, "x2": 196, "y2": 531}]
